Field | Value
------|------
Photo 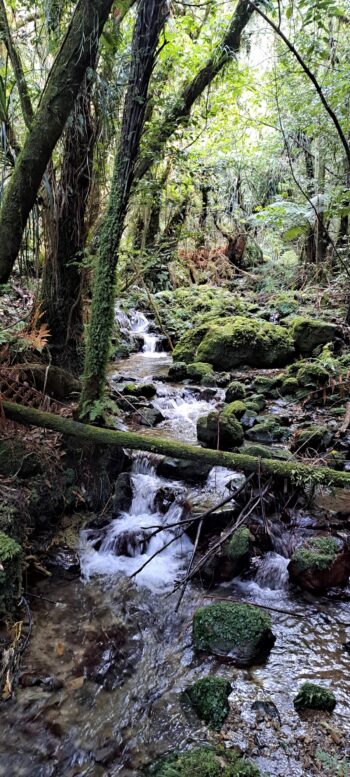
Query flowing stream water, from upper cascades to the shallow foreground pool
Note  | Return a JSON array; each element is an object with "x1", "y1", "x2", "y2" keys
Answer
[{"x1": 0, "y1": 314, "x2": 350, "y2": 777}]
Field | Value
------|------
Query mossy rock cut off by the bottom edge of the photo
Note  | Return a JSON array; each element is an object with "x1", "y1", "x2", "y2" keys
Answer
[{"x1": 145, "y1": 746, "x2": 260, "y2": 777}]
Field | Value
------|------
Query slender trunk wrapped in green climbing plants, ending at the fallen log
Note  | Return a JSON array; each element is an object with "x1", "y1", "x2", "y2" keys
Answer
[{"x1": 80, "y1": 0, "x2": 167, "y2": 416}]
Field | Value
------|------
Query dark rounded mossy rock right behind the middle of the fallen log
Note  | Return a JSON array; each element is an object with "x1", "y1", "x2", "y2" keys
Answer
[{"x1": 197, "y1": 406, "x2": 243, "y2": 451}]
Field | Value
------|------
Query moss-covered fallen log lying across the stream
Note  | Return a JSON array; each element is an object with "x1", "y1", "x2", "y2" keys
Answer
[{"x1": 2, "y1": 402, "x2": 350, "y2": 488}]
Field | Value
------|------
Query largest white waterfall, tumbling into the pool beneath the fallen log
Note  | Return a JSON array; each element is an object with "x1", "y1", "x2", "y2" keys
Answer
[{"x1": 81, "y1": 456, "x2": 192, "y2": 591}]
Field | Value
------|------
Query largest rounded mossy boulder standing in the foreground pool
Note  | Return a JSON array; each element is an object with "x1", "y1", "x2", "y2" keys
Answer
[{"x1": 193, "y1": 602, "x2": 275, "y2": 666}]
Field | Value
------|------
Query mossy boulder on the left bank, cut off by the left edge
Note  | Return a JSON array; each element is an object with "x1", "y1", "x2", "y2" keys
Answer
[{"x1": 0, "y1": 532, "x2": 22, "y2": 618}]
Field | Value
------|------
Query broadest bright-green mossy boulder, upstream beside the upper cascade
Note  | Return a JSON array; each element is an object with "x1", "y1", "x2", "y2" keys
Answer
[{"x1": 173, "y1": 316, "x2": 294, "y2": 370}]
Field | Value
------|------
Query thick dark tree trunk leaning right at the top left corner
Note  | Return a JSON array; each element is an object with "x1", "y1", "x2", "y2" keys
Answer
[{"x1": 0, "y1": 0, "x2": 113, "y2": 283}]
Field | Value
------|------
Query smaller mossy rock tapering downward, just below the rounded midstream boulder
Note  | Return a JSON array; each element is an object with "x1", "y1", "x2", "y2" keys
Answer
[{"x1": 184, "y1": 676, "x2": 232, "y2": 731}]
